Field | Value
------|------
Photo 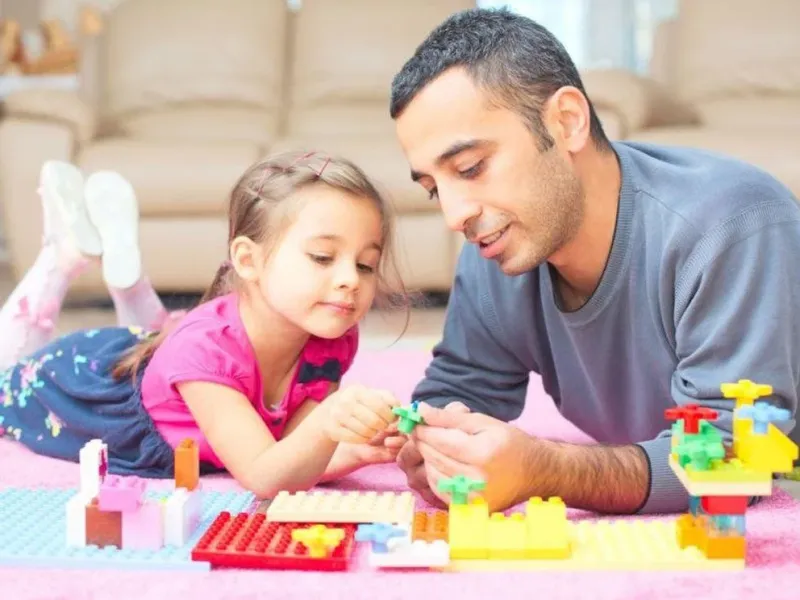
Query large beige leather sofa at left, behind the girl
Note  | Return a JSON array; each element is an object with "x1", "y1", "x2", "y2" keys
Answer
[{"x1": 0, "y1": 0, "x2": 474, "y2": 296}]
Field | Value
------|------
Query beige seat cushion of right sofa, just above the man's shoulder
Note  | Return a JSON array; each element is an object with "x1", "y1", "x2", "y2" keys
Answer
[{"x1": 628, "y1": 127, "x2": 800, "y2": 197}]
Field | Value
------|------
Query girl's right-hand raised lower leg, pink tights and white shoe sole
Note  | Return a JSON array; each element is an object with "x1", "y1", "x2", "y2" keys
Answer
[{"x1": 85, "y1": 171, "x2": 168, "y2": 329}]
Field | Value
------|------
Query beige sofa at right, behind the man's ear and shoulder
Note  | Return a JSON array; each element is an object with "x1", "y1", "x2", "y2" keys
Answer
[{"x1": 583, "y1": 0, "x2": 800, "y2": 197}]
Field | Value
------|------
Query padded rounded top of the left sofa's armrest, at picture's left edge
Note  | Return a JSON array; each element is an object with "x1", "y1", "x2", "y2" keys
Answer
[{"x1": 3, "y1": 89, "x2": 97, "y2": 144}]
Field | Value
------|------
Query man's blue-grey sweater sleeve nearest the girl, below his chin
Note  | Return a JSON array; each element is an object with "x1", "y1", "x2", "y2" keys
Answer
[{"x1": 412, "y1": 246, "x2": 530, "y2": 421}]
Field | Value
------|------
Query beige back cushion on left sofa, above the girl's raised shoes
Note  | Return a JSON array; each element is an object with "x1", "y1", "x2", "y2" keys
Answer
[{"x1": 100, "y1": 0, "x2": 288, "y2": 118}]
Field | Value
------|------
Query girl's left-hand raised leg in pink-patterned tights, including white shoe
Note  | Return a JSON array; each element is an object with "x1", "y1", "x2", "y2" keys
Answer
[{"x1": 0, "y1": 161, "x2": 101, "y2": 369}]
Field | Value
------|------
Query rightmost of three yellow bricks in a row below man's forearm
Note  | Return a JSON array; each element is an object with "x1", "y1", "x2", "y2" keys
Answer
[{"x1": 525, "y1": 497, "x2": 570, "y2": 559}]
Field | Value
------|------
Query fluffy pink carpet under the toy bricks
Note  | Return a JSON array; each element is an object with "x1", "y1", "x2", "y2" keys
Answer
[{"x1": 0, "y1": 350, "x2": 800, "y2": 600}]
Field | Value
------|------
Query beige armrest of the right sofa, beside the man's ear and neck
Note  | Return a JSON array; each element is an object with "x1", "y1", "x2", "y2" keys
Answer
[{"x1": 581, "y1": 69, "x2": 700, "y2": 135}]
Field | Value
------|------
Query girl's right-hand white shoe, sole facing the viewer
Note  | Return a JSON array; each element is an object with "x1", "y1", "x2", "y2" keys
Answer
[{"x1": 84, "y1": 171, "x2": 142, "y2": 289}]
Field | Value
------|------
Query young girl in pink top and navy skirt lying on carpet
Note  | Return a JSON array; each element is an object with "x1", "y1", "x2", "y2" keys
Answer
[{"x1": 0, "y1": 153, "x2": 410, "y2": 497}]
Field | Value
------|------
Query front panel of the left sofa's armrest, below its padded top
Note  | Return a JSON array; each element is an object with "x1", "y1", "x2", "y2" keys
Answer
[{"x1": 0, "y1": 118, "x2": 75, "y2": 278}]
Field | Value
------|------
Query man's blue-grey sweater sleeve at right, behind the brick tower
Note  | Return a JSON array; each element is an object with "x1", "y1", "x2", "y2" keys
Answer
[{"x1": 639, "y1": 202, "x2": 800, "y2": 513}]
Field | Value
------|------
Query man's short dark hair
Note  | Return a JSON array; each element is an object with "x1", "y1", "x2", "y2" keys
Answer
[{"x1": 389, "y1": 8, "x2": 610, "y2": 150}]
